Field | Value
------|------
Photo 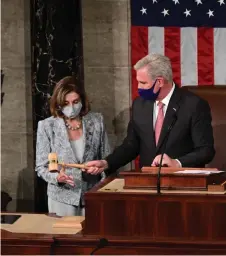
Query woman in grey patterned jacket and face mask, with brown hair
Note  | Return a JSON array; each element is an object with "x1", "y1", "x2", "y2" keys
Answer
[{"x1": 35, "y1": 77, "x2": 110, "y2": 216}]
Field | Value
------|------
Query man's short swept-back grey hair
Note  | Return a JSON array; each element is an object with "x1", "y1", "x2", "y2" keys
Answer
[{"x1": 134, "y1": 54, "x2": 173, "y2": 83}]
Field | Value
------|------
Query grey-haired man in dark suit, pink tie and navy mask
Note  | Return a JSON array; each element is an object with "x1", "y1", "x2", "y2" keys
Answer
[{"x1": 87, "y1": 54, "x2": 215, "y2": 174}]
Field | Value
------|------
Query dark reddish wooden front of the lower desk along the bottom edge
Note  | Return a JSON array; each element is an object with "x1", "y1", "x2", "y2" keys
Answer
[{"x1": 1, "y1": 230, "x2": 226, "y2": 255}]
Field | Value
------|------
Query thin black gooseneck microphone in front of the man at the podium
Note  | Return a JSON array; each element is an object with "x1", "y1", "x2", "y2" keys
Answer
[{"x1": 157, "y1": 108, "x2": 177, "y2": 194}]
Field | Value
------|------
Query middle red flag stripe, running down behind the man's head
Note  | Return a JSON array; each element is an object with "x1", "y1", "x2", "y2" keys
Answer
[{"x1": 164, "y1": 27, "x2": 181, "y2": 86}]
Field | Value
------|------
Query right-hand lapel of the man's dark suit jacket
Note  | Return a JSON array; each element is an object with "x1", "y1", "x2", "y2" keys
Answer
[{"x1": 156, "y1": 86, "x2": 181, "y2": 152}]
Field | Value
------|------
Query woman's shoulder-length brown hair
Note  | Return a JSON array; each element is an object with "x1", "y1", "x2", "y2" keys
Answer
[{"x1": 50, "y1": 76, "x2": 90, "y2": 117}]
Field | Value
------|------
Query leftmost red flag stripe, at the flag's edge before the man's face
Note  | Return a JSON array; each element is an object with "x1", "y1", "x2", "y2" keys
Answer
[{"x1": 131, "y1": 26, "x2": 148, "y2": 99}]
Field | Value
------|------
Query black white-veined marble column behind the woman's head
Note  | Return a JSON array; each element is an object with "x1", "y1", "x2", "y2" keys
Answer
[{"x1": 31, "y1": 0, "x2": 83, "y2": 124}]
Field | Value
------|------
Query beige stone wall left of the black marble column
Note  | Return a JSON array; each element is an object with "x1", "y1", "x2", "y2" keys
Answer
[{"x1": 1, "y1": 0, "x2": 34, "y2": 211}]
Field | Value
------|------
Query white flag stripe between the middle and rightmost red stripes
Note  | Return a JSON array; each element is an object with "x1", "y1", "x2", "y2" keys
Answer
[{"x1": 181, "y1": 28, "x2": 198, "y2": 86}]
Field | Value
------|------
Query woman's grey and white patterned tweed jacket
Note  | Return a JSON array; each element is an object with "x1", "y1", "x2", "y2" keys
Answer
[{"x1": 35, "y1": 112, "x2": 110, "y2": 206}]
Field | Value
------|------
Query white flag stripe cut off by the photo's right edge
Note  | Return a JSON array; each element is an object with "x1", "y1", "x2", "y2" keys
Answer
[{"x1": 214, "y1": 28, "x2": 226, "y2": 85}]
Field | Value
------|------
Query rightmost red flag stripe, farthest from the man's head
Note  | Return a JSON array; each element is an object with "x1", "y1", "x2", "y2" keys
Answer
[{"x1": 197, "y1": 27, "x2": 214, "y2": 85}]
